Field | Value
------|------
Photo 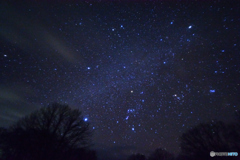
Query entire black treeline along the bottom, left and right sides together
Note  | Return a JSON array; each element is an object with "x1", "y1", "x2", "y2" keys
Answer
[{"x1": 0, "y1": 103, "x2": 240, "y2": 160}]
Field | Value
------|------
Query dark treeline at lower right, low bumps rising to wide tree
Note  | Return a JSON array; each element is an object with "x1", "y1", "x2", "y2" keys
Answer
[{"x1": 128, "y1": 111, "x2": 240, "y2": 160}]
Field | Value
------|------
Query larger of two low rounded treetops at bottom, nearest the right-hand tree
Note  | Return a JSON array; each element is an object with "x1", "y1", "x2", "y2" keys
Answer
[{"x1": 148, "y1": 148, "x2": 174, "y2": 160}]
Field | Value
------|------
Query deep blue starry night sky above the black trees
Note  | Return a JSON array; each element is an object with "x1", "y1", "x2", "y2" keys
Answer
[{"x1": 0, "y1": 0, "x2": 240, "y2": 158}]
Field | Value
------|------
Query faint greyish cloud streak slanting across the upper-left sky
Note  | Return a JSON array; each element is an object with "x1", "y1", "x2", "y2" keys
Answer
[{"x1": 0, "y1": 4, "x2": 79, "y2": 63}]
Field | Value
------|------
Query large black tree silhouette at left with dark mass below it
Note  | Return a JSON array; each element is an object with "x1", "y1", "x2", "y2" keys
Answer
[{"x1": 0, "y1": 103, "x2": 91, "y2": 160}]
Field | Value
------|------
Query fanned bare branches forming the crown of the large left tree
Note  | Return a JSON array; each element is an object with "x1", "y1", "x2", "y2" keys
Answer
[{"x1": 13, "y1": 103, "x2": 91, "y2": 147}]
